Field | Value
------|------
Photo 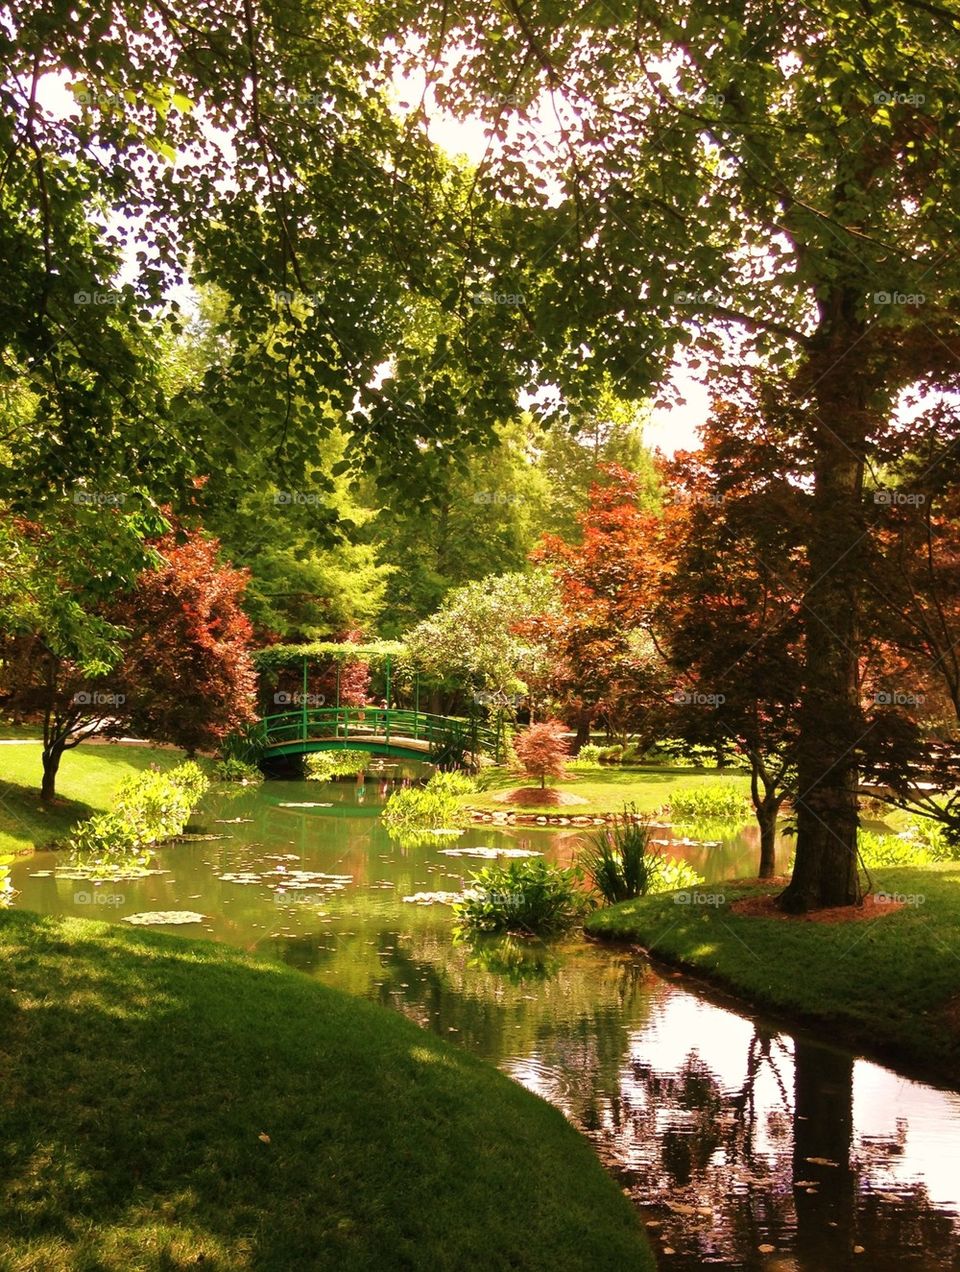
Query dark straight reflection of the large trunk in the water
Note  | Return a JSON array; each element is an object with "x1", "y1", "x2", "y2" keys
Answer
[{"x1": 793, "y1": 1039, "x2": 857, "y2": 1272}]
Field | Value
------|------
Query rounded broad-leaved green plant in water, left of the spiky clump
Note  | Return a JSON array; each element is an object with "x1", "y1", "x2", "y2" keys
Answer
[{"x1": 454, "y1": 857, "x2": 590, "y2": 935}]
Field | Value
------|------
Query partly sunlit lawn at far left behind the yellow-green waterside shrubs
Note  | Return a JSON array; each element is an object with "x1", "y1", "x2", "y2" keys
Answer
[{"x1": 0, "y1": 729, "x2": 199, "y2": 856}]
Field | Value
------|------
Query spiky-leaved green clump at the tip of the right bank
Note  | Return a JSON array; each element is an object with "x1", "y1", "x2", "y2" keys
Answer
[{"x1": 580, "y1": 805, "x2": 703, "y2": 906}]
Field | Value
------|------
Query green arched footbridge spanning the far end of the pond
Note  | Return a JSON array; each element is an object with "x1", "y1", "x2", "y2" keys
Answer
[{"x1": 262, "y1": 707, "x2": 502, "y2": 764}]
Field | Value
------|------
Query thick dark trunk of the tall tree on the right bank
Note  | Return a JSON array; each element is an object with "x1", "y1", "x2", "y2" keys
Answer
[{"x1": 781, "y1": 318, "x2": 867, "y2": 913}]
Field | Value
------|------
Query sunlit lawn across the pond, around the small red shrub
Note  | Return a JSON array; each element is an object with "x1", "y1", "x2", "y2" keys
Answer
[{"x1": 470, "y1": 764, "x2": 750, "y2": 817}]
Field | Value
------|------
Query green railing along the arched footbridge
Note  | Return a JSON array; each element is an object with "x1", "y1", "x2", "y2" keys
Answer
[{"x1": 262, "y1": 707, "x2": 500, "y2": 756}]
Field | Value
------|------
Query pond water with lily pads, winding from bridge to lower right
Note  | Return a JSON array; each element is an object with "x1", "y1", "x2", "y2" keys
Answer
[{"x1": 14, "y1": 767, "x2": 960, "y2": 1272}]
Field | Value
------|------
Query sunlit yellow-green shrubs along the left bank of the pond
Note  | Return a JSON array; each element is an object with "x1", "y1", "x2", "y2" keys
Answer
[{"x1": 67, "y1": 761, "x2": 209, "y2": 869}]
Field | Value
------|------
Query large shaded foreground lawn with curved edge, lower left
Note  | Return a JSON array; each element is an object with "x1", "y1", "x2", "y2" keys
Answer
[{"x1": 0, "y1": 911, "x2": 654, "y2": 1272}]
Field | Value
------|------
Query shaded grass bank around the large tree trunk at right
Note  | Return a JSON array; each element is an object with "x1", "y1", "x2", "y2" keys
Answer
[{"x1": 586, "y1": 862, "x2": 960, "y2": 1085}]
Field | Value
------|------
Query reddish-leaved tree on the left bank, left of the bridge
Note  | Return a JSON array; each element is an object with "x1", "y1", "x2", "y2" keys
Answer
[{"x1": 111, "y1": 530, "x2": 256, "y2": 753}]
